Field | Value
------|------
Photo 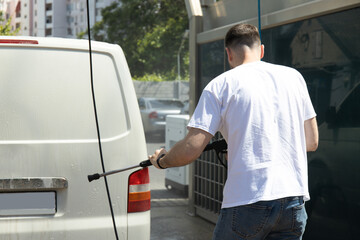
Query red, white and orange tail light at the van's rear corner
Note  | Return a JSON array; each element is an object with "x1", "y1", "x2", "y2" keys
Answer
[{"x1": 128, "y1": 167, "x2": 151, "y2": 213}]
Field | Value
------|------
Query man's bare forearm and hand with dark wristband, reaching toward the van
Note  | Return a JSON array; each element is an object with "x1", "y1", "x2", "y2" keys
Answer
[{"x1": 149, "y1": 128, "x2": 213, "y2": 169}]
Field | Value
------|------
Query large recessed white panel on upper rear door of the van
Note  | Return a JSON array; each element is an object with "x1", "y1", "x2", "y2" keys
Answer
[{"x1": 0, "y1": 47, "x2": 129, "y2": 141}]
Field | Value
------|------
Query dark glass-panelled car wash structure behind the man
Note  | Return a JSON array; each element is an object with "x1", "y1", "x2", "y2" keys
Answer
[{"x1": 185, "y1": 0, "x2": 360, "y2": 240}]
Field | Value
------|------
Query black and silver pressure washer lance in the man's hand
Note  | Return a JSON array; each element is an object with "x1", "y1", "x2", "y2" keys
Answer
[{"x1": 88, "y1": 139, "x2": 227, "y2": 182}]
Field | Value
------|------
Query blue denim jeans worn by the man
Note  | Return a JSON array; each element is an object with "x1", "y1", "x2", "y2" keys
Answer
[{"x1": 213, "y1": 197, "x2": 307, "y2": 240}]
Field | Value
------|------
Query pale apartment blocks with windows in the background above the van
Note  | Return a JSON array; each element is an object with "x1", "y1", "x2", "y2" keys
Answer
[{"x1": 0, "y1": 0, "x2": 116, "y2": 38}]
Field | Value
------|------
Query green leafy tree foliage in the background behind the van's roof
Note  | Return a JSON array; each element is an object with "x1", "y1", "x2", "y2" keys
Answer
[{"x1": 91, "y1": 0, "x2": 189, "y2": 79}]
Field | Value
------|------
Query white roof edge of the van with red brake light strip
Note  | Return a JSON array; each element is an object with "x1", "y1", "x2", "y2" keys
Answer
[{"x1": 0, "y1": 36, "x2": 120, "y2": 51}]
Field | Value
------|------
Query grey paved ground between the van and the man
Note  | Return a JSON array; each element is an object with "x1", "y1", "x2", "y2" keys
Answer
[{"x1": 147, "y1": 133, "x2": 215, "y2": 240}]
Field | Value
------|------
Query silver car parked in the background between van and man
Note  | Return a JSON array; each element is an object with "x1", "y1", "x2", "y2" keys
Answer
[{"x1": 138, "y1": 97, "x2": 184, "y2": 134}]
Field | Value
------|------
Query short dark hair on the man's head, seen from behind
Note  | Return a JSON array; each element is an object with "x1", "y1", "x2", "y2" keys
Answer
[{"x1": 225, "y1": 24, "x2": 261, "y2": 48}]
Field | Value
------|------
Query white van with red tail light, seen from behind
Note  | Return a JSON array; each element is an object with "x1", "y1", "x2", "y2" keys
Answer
[{"x1": 0, "y1": 37, "x2": 150, "y2": 240}]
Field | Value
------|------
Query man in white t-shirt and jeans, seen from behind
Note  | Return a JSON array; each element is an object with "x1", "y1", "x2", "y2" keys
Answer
[{"x1": 149, "y1": 24, "x2": 318, "y2": 240}]
